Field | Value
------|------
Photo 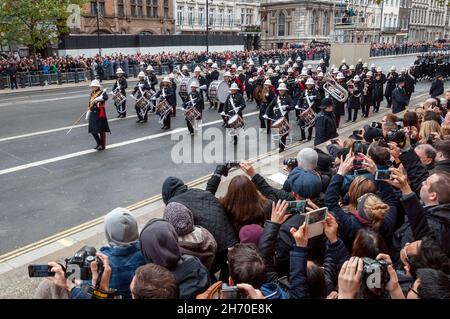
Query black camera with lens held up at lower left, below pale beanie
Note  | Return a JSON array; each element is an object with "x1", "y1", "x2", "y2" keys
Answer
[{"x1": 66, "y1": 246, "x2": 103, "y2": 280}]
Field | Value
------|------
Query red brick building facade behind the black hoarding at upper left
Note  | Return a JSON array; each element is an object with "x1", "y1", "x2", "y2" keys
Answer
[{"x1": 71, "y1": 0, "x2": 175, "y2": 34}]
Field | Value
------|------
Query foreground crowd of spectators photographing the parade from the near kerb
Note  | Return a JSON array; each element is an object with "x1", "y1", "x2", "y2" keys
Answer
[{"x1": 29, "y1": 91, "x2": 450, "y2": 299}]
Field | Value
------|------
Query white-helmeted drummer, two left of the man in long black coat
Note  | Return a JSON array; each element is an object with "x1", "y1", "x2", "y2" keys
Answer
[{"x1": 265, "y1": 83, "x2": 294, "y2": 153}]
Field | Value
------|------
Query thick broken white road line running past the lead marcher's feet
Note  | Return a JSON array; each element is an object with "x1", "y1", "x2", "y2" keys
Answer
[{"x1": 0, "y1": 111, "x2": 259, "y2": 175}]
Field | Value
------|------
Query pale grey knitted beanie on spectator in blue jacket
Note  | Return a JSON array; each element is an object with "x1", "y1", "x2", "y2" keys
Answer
[{"x1": 105, "y1": 207, "x2": 139, "y2": 247}]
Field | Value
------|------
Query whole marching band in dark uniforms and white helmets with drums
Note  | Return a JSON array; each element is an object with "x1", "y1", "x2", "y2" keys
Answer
[{"x1": 79, "y1": 54, "x2": 450, "y2": 152}]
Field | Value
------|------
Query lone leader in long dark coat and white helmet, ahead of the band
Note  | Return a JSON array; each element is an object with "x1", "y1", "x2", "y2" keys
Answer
[{"x1": 88, "y1": 80, "x2": 111, "y2": 151}]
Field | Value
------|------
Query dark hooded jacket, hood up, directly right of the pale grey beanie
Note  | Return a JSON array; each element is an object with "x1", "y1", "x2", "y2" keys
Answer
[{"x1": 139, "y1": 219, "x2": 209, "y2": 299}]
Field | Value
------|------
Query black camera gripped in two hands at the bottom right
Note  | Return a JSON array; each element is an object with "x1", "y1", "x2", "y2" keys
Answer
[{"x1": 362, "y1": 257, "x2": 390, "y2": 294}]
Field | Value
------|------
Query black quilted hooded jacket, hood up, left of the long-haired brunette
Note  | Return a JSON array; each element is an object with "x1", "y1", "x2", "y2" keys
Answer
[{"x1": 162, "y1": 176, "x2": 239, "y2": 252}]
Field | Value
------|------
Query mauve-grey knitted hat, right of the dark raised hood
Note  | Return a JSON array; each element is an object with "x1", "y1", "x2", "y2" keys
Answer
[{"x1": 163, "y1": 202, "x2": 194, "y2": 236}]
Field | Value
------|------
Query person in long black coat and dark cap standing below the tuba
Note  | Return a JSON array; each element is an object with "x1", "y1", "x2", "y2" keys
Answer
[{"x1": 314, "y1": 98, "x2": 338, "y2": 146}]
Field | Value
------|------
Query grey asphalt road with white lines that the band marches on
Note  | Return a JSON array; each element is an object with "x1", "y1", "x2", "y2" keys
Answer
[{"x1": 0, "y1": 54, "x2": 440, "y2": 254}]
